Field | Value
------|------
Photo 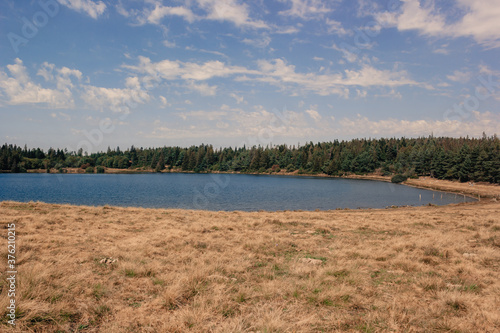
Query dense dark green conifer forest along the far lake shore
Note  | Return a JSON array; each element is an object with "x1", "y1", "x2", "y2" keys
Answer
[{"x1": 0, "y1": 135, "x2": 500, "y2": 183}]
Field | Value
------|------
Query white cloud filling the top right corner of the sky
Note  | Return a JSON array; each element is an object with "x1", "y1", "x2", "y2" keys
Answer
[{"x1": 374, "y1": 0, "x2": 500, "y2": 48}]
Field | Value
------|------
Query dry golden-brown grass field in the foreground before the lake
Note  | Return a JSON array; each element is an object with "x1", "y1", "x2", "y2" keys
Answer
[{"x1": 0, "y1": 201, "x2": 500, "y2": 332}]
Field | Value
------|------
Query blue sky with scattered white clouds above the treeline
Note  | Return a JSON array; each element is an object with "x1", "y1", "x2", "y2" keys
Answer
[{"x1": 0, "y1": 0, "x2": 500, "y2": 152}]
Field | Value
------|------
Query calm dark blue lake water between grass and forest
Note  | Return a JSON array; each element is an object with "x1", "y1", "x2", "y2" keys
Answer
[{"x1": 0, "y1": 173, "x2": 474, "y2": 211}]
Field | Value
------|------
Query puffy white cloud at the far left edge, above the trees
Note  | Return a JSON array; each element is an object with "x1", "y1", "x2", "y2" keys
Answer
[{"x1": 0, "y1": 58, "x2": 76, "y2": 108}]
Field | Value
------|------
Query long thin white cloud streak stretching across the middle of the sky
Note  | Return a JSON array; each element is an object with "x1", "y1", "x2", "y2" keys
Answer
[{"x1": 123, "y1": 56, "x2": 426, "y2": 98}]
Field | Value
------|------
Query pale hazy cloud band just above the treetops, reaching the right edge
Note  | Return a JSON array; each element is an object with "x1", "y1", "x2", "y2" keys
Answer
[{"x1": 144, "y1": 107, "x2": 500, "y2": 145}]
